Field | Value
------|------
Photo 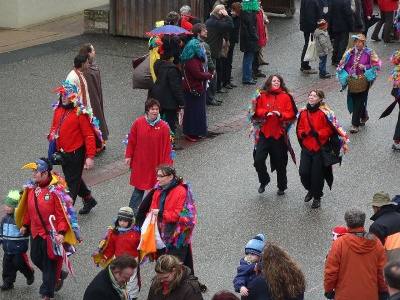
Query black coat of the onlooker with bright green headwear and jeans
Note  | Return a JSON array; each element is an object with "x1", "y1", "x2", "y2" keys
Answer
[{"x1": 240, "y1": 11, "x2": 258, "y2": 52}]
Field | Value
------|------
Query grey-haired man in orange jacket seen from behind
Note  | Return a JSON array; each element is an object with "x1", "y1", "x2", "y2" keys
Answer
[{"x1": 324, "y1": 208, "x2": 387, "y2": 300}]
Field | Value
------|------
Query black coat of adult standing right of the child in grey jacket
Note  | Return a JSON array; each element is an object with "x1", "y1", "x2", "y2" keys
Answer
[{"x1": 331, "y1": 0, "x2": 353, "y2": 32}]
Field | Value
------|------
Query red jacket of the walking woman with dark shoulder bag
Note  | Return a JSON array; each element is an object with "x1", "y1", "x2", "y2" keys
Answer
[{"x1": 297, "y1": 109, "x2": 333, "y2": 151}]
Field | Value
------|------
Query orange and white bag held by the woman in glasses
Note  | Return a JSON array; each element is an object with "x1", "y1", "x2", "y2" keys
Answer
[{"x1": 138, "y1": 212, "x2": 165, "y2": 253}]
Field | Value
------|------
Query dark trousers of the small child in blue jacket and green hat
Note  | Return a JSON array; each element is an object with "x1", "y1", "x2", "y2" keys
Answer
[{"x1": 2, "y1": 253, "x2": 34, "y2": 284}]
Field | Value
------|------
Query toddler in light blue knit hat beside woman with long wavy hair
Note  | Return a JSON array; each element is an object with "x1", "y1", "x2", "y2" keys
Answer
[{"x1": 233, "y1": 233, "x2": 264, "y2": 297}]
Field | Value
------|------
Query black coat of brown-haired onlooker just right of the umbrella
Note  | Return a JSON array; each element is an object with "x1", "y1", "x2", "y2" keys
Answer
[{"x1": 204, "y1": 15, "x2": 233, "y2": 58}]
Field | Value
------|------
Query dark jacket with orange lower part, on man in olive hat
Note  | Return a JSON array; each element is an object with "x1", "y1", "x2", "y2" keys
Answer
[{"x1": 369, "y1": 205, "x2": 400, "y2": 261}]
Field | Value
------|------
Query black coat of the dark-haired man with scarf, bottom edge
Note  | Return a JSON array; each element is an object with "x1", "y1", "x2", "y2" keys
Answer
[{"x1": 83, "y1": 268, "x2": 121, "y2": 300}]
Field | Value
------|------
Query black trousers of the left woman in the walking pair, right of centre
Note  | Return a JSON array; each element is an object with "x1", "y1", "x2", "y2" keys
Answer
[{"x1": 254, "y1": 131, "x2": 288, "y2": 190}]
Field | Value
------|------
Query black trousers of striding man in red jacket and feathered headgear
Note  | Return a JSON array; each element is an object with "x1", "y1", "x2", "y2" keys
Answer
[{"x1": 62, "y1": 146, "x2": 91, "y2": 204}]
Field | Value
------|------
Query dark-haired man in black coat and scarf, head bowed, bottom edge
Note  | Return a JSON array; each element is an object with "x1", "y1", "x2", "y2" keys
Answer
[{"x1": 83, "y1": 254, "x2": 137, "y2": 300}]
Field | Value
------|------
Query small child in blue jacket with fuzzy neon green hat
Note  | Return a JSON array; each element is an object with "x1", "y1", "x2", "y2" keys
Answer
[{"x1": 0, "y1": 190, "x2": 35, "y2": 291}]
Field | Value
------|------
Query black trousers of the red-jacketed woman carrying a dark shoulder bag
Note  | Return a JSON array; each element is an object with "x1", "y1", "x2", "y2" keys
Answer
[{"x1": 299, "y1": 148, "x2": 325, "y2": 198}]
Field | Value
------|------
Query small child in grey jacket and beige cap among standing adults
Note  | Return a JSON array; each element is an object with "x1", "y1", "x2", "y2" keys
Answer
[{"x1": 314, "y1": 19, "x2": 333, "y2": 79}]
